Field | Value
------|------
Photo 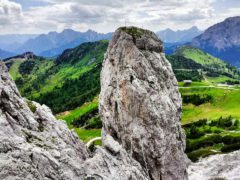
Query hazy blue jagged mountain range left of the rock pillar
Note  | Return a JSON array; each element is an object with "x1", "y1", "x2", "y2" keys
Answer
[{"x1": 15, "y1": 29, "x2": 112, "y2": 57}]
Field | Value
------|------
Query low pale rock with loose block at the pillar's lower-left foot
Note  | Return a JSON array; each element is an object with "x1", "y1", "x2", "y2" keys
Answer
[{"x1": 85, "y1": 129, "x2": 150, "y2": 180}]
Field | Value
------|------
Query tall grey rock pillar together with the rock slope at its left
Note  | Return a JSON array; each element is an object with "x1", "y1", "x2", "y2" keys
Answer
[{"x1": 0, "y1": 27, "x2": 187, "y2": 180}]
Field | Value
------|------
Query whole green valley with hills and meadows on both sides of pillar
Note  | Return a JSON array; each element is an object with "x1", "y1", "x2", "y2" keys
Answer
[{"x1": 5, "y1": 38, "x2": 240, "y2": 161}]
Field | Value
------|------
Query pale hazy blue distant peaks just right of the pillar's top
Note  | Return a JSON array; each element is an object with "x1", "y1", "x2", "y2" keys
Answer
[{"x1": 157, "y1": 26, "x2": 202, "y2": 43}]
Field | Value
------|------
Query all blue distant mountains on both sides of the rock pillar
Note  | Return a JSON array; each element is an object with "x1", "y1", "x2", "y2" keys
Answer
[{"x1": 0, "y1": 16, "x2": 240, "y2": 67}]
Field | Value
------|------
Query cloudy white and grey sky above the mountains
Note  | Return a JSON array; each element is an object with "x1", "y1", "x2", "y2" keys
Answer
[{"x1": 0, "y1": 0, "x2": 240, "y2": 34}]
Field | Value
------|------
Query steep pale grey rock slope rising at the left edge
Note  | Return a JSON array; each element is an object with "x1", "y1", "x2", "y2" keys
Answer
[{"x1": 0, "y1": 62, "x2": 88, "y2": 180}]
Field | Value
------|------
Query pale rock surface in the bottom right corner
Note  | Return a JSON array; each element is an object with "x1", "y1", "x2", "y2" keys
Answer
[{"x1": 188, "y1": 151, "x2": 240, "y2": 180}]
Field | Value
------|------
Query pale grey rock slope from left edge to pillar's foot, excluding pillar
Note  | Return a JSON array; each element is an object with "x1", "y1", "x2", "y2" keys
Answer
[{"x1": 0, "y1": 59, "x2": 148, "y2": 180}]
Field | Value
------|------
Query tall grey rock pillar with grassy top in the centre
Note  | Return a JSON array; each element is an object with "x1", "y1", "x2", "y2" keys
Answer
[{"x1": 99, "y1": 27, "x2": 187, "y2": 180}]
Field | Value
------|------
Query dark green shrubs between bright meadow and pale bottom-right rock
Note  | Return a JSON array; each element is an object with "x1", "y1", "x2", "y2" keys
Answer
[{"x1": 183, "y1": 116, "x2": 240, "y2": 161}]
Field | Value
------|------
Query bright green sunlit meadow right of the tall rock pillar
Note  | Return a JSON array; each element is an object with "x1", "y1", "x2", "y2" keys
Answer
[{"x1": 180, "y1": 87, "x2": 240, "y2": 124}]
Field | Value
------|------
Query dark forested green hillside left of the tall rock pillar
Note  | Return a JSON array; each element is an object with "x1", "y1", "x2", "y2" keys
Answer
[{"x1": 6, "y1": 41, "x2": 108, "y2": 112}]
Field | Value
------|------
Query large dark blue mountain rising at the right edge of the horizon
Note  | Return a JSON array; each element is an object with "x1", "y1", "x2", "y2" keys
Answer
[{"x1": 191, "y1": 16, "x2": 240, "y2": 67}]
